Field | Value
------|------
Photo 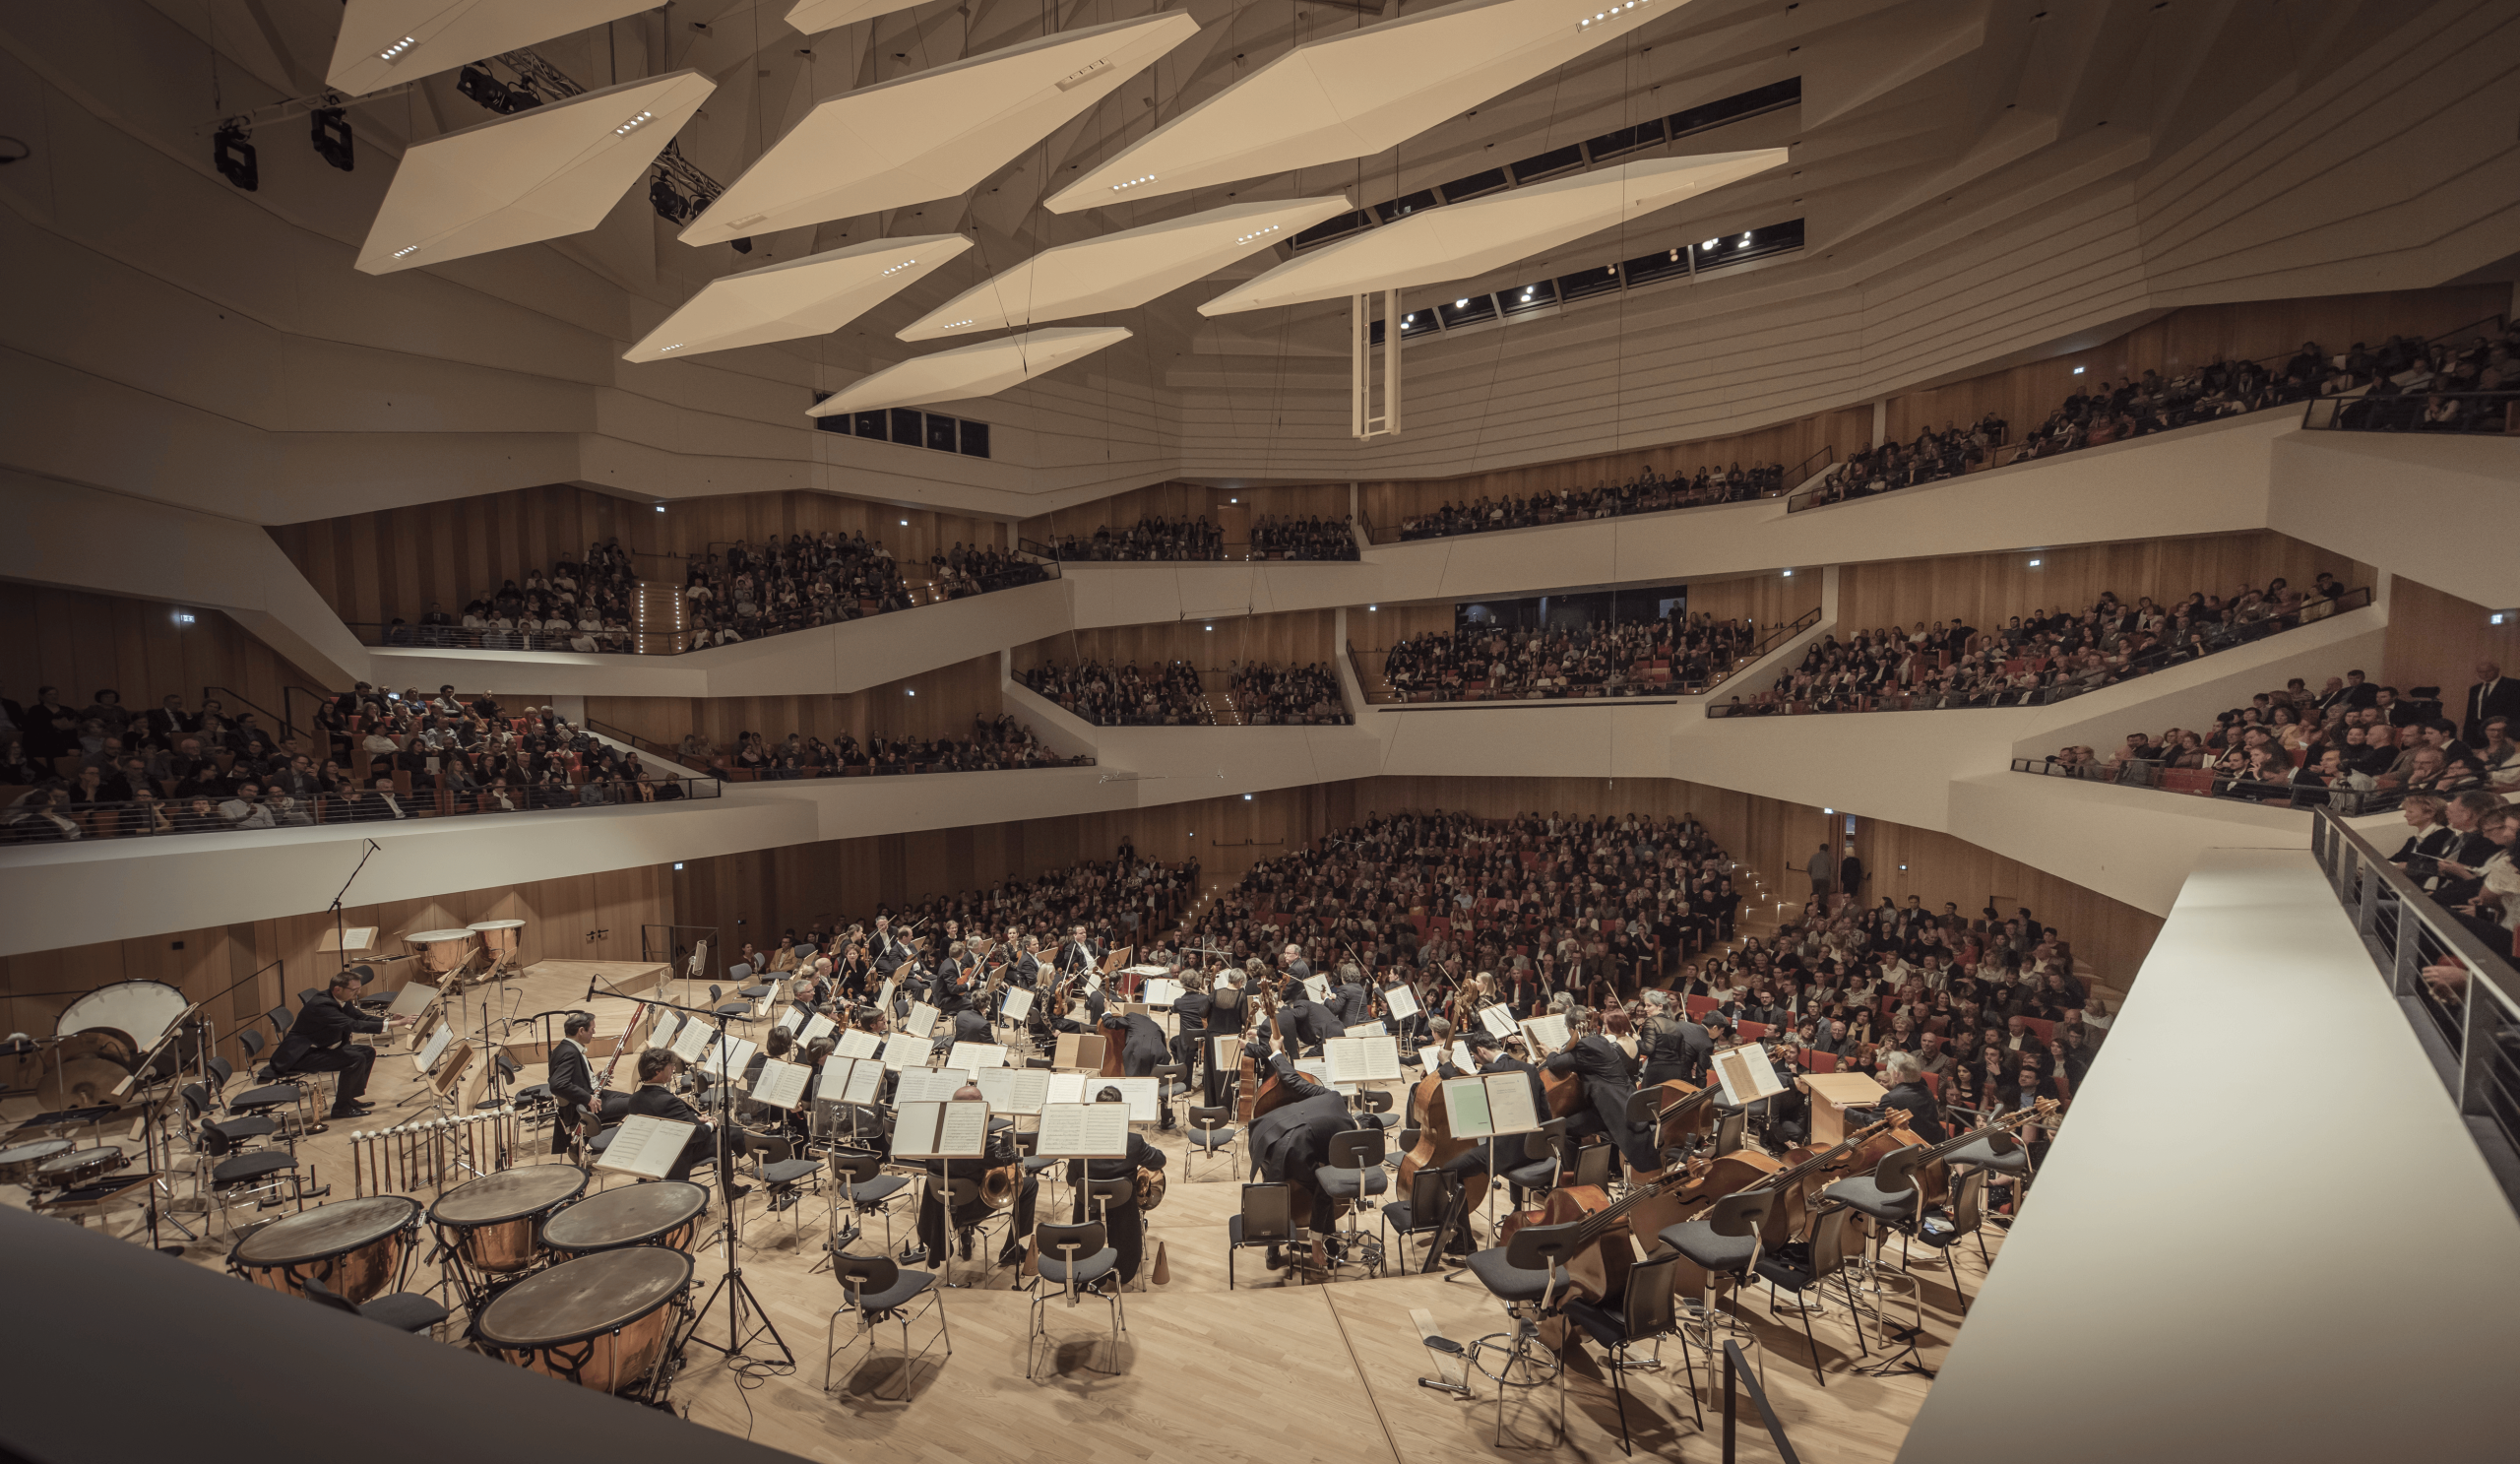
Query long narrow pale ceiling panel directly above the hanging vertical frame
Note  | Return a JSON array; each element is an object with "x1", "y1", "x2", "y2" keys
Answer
[{"x1": 1200, "y1": 149, "x2": 1787, "y2": 315}]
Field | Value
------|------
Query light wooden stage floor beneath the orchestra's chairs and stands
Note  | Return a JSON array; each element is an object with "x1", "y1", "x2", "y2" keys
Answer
[{"x1": 0, "y1": 1017, "x2": 1965, "y2": 1464}]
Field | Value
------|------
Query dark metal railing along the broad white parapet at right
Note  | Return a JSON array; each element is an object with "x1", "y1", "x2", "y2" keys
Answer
[{"x1": 2311, "y1": 809, "x2": 2520, "y2": 1210}]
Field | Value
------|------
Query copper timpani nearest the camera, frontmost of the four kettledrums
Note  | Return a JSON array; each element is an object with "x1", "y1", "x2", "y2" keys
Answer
[{"x1": 473, "y1": 1244, "x2": 690, "y2": 1393}]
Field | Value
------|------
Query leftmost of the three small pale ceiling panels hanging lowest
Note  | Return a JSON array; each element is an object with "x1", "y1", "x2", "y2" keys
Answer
[{"x1": 622, "y1": 234, "x2": 971, "y2": 360}]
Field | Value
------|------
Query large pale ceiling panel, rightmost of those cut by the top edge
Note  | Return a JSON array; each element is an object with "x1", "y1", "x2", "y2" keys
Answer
[{"x1": 1048, "y1": 0, "x2": 1688, "y2": 215}]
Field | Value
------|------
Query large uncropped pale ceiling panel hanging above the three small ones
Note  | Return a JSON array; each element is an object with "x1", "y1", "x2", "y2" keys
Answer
[{"x1": 683, "y1": 13, "x2": 1200, "y2": 244}]
